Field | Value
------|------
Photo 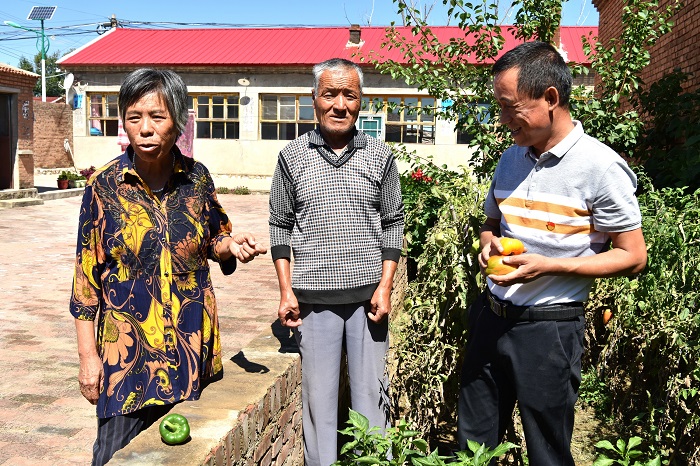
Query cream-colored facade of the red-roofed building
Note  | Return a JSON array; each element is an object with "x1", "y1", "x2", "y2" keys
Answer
[{"x1": 68, "y1": 70, "x2": 471, "y2": 191}]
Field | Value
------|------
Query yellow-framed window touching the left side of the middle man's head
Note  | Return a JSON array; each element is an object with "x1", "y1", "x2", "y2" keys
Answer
[{"x1": 260, "y1": 94, "x2": 316, "y2": 140}]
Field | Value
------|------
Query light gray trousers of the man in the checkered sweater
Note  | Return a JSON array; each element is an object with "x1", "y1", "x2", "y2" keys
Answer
[{"x1": 294, "y1": 301, "x2": 389, "y2": 466}]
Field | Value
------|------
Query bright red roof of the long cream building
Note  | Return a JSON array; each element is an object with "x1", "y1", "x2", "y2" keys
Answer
[{"x1": 59, "y1": 26, "x2": 598, "y2": 68}]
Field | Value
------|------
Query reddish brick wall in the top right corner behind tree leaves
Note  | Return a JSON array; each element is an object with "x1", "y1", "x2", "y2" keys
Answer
[{"x1": 593, "y1": 0, "x2": 700, "y2": 91}]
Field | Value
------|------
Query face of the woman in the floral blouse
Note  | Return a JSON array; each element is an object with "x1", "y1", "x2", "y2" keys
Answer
[{"x1": 124, "y1": 92, "x2": 177, "y2": 163}]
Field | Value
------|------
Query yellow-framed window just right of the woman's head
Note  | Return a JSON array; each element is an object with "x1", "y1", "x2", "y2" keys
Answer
[{"x1": 187, "y1": 94, "x2": 240, "y2": 139}]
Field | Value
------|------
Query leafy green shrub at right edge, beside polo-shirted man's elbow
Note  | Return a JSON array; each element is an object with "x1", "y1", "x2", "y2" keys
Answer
[{"x1": 588, "y1": 177, "x2": 700, "y2": 465}]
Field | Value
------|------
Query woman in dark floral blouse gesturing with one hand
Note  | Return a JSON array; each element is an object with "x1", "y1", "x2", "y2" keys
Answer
[{"x1": 70, "y1": 69, "x2": 266, "y2": 465}]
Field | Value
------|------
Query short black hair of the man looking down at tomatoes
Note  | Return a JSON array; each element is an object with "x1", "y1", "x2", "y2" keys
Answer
[{"x1": 492, "y1": 42, "x2": 573, "y2": 108}]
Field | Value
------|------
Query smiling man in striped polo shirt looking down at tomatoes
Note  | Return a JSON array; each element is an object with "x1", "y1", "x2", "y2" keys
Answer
[{"x1": 458, "y1": 42, "x2": 646, "y2": 466}]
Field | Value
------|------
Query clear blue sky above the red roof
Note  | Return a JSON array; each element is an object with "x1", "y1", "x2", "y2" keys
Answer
[{"x1": 0, "y1": 0, "x2": 598, "y2": 66}]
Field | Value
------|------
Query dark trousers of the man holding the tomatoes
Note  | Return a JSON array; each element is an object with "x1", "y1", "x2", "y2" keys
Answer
[{"x1": 457, "y1": 295, "x2": 585, "y2": 466}]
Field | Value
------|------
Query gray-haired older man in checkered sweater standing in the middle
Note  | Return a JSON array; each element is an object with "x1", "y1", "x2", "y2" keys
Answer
[{"x1": 270, "y1": 59, "x2": 403, "y2": 466}]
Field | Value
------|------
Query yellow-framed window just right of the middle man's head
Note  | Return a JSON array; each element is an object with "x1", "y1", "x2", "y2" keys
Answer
[{"x1": 362, "y1": 96, "x2": 435, "y2": 144}]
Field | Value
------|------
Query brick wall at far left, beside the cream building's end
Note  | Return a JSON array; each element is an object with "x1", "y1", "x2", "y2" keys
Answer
[{"x1": 34, "y1": 102, "x2": 73, "y2": 168}]
